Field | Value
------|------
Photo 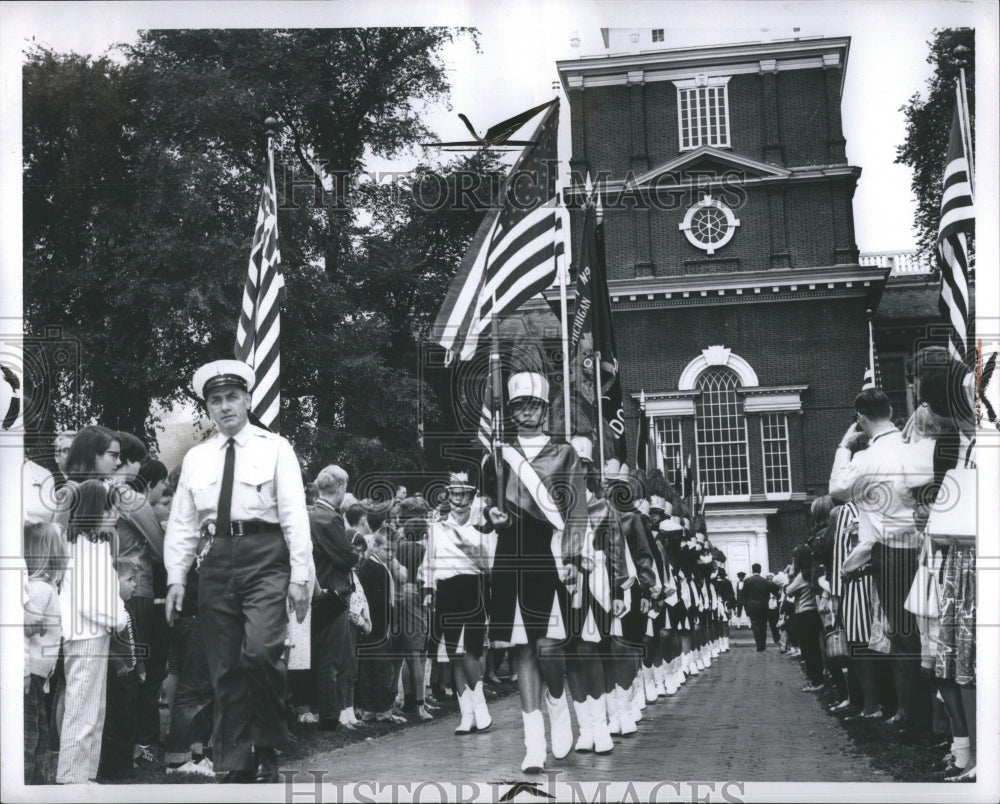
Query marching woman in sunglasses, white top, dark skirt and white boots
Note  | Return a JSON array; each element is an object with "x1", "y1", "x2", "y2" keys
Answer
[{"x1": 424, "y1": 472, "x2": 493, "y2": 734}]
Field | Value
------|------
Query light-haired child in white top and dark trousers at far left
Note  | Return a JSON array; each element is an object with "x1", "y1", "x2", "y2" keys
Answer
[{"x1": 24, "y1": 522, "x2": 68, "y2": 784}]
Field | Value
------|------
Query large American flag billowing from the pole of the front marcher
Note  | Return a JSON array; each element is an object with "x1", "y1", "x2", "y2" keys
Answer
[{"x1": 434, "y1": 100, "x2": 569, "y2": 363}]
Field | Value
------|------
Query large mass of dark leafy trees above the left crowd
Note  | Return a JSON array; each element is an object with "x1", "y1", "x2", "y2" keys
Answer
[{"x1": 24, "y1": 29, "x2": 492, "y2": 484}]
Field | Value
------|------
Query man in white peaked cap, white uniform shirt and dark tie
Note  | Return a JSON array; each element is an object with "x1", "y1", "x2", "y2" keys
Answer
[{"x1": 164, "y1": 360, "x2": 312, "y2": 782}]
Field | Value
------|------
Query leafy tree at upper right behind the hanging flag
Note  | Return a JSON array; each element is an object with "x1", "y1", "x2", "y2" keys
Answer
[{"x1": 896, "y1": 28, "x2": 976, "y2": 250}]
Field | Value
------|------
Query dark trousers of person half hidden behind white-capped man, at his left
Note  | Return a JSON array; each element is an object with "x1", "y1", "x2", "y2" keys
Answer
[{"x1": 164, "y1": 617, "x2": 212, "y2": 763}]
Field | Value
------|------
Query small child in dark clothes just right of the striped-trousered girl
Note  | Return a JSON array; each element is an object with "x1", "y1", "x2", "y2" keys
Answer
[{"x1": 97, "y1": 557, "x2": 144, "y2": 781}]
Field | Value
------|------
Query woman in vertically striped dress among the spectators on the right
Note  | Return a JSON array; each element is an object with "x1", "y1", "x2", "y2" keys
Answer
[{"x1": 830, "y1": 502, "x2": 882, "y2": 718}]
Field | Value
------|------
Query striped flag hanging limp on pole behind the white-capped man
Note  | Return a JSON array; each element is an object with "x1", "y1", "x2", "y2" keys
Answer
[{"x1": 235, "y1": 137, "x2": 285, "y2": 431}]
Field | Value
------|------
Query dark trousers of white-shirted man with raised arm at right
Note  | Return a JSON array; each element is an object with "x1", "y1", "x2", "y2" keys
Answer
[{"x1": 872, "y1": 542, "x2": 931, "y2": 731}]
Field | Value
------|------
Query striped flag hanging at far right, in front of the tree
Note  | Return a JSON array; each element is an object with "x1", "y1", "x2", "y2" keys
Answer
[{"x1": 937, "y1": 92, "x2": 976, "y2": 361}]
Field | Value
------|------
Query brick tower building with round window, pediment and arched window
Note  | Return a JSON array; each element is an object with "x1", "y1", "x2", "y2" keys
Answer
[{"x1": 557, "y1": 31, "x2": 902, "y2": 573}]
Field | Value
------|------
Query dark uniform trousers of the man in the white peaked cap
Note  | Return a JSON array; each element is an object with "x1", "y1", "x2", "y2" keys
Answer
[{"x1": 198, "y1": 530, "x2": 291, "y2": 772}]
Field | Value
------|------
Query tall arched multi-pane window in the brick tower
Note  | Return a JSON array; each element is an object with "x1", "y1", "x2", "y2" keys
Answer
[{"x1": 695, "y1": 366, "x2": 750, "y2": 497}]
